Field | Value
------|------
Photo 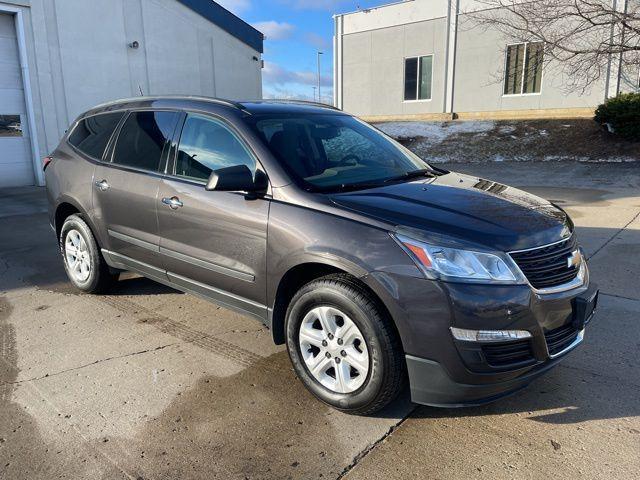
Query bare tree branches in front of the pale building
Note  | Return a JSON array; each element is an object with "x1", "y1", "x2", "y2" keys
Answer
[{"x1": 465, "y1": 0, "x2": 640, "y2": 92}]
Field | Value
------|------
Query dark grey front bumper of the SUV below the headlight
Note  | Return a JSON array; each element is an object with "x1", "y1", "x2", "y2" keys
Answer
[{"x1": 364, "y1": 268, "x2": 598, "y2": 407}]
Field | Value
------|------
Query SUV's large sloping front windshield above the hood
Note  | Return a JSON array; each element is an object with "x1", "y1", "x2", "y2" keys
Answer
[{"x1": 245, "y1": 114, "x2": 436, "y2": 191}]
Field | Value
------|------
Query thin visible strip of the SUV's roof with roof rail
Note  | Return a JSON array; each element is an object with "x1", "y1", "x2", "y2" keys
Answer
[{"x1": 85, "y1": 95, "x2": 340, "y2": 115}]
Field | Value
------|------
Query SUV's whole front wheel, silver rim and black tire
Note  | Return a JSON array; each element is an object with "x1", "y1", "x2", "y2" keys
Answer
[{"x1": 286, "y1": 275, "x2": 406, "y2": 415}]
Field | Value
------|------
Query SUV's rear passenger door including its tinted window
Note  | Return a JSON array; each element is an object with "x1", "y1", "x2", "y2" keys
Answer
[{"x1": 93, "y1": 111, "x2": 179, "y2": 276}]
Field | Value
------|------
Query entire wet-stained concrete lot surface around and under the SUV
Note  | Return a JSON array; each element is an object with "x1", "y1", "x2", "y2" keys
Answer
[{"x1": 0, "y1": 162, "x2": 640, "y2": 479}]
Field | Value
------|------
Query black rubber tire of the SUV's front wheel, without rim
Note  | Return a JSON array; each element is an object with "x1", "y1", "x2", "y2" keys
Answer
[{"x1": 285, "y1": 274, "x2": 407, "y2": 415}]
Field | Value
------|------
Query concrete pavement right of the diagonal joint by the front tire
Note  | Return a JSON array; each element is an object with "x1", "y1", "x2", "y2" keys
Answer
[{"x1": 346, "y1": 163, "x2": 640, "y2": 480}]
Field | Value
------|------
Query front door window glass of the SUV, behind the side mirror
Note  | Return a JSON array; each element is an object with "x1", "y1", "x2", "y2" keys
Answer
[{"x1": 176, "y1": 115, "x2": 256, "y2": 181}]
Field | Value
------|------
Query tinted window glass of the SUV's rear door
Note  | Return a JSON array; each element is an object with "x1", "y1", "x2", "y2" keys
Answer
[{"x1": 113, "y1": 112, "x2": 177, "y2": 171}]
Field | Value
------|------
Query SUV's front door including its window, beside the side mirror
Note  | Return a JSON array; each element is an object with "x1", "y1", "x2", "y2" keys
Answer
[{"x1": 157, "y1": 114, "x2": 269, "y2": 318}]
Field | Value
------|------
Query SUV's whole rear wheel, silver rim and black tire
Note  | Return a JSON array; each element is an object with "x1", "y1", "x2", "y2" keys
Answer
[{"x1": 59, "y1": 214, "x2": 117, "y2": 293}]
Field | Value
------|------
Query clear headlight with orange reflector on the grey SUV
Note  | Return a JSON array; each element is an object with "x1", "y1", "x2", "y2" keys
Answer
[{"x1": 394, "y1": 235, "x2": 524, "y2": 284}]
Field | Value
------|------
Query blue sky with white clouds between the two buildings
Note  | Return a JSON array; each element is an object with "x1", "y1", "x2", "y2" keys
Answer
[{"x1": 216, "y1": 0, "x2": 384, "y2": 102}]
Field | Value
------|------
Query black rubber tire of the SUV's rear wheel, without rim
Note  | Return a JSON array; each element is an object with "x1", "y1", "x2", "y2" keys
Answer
[{"x1": 59, "y1": 214, "x2": 118, "y2": 293}]
